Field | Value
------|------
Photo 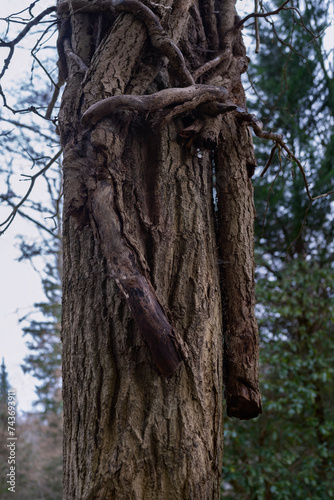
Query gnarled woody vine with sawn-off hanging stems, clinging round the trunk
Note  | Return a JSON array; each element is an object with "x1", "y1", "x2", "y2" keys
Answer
[{"x1": 58, "y1": 0, "x2": 332, "y2": 419}]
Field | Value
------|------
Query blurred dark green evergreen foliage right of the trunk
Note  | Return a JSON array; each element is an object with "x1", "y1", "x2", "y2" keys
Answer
[{"x1": 224, "y1": 1, "x2": 334, "y2": 500}]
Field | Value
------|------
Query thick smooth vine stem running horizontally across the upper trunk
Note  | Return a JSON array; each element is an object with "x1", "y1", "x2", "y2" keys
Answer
[{"x1": 82, "y1": 85, "x2": 227, "y2": 125}]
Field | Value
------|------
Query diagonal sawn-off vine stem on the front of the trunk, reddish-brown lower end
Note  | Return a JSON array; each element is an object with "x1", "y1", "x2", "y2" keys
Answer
[{"x1": 91, "y1": 181, "x2": 182, "y2": 377}]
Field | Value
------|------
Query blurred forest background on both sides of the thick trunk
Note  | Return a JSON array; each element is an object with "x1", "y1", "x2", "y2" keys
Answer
[{"x1": 0, "y1": 0, "x2": 334, "y2": 500}]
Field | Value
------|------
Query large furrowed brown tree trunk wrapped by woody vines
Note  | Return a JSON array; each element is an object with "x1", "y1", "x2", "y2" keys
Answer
[{"x1": 58, "y1": 0, "x2": 260, "y2": 500}]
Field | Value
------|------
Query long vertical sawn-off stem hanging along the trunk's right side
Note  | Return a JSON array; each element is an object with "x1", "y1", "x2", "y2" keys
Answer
[{"x1": 216, "y1": 116, "x2": 262, "y2": 420}]
